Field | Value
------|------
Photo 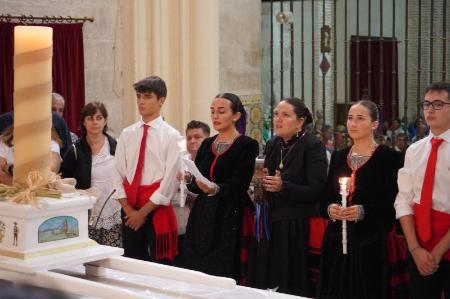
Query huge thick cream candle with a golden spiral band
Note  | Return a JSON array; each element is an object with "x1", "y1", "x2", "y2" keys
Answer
[{"x1": 14, "y1": 26, "x2": 53, "y2": 185}]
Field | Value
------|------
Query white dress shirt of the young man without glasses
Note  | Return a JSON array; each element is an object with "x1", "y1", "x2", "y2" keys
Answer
[{"x1": 114, "y1": 116, "x2": 181, "y2": 206}]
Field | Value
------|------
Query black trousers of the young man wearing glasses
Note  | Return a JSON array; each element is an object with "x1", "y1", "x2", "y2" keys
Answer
[{"x1": 408, "y1": 257, "x2": 450, "y2": 299}]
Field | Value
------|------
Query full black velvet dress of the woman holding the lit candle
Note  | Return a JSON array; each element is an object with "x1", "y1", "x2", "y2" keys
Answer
[{"x1": 317, "y1": 145, "x2": 403, "y2": 299}]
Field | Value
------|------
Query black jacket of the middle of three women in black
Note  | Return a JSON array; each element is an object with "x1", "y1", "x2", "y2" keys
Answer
[{"x1": 264, "y1": 133, "x2": 328, "y2": 221}]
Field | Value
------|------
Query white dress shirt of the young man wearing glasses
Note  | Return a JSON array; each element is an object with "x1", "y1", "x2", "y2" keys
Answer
[{"x1": 394, "y1": 129, "x2": 450, "y2": 218}]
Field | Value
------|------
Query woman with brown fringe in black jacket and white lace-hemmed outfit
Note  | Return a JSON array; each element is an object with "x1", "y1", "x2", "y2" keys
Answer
[{"x1": 61, "y1": 102, "x2": 122, "y2": 247}]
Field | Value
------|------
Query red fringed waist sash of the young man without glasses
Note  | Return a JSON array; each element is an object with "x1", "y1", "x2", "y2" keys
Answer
[{"x1": 123, "y1": 180, "x2": 178, "y2": 260}]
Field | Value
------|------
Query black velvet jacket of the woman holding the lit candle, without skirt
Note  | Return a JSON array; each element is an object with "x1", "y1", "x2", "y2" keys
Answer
[{"x1": 320, "y1": 145, "x2": 404, "y2": 238}]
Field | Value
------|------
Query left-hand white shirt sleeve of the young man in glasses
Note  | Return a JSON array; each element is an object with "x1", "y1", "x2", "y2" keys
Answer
[{"x1": 394, "y1": 151, "x2": 414, "y2": 219}]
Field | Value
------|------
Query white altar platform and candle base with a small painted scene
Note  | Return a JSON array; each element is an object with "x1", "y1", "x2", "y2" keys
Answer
[{"x1": 0, "y1": 194, "x2": 298, "y2": 299}]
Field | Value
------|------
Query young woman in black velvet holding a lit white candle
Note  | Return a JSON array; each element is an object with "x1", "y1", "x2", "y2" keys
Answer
[{"x1": 317, "y1": 100, "x2": 403, "y2": 299}]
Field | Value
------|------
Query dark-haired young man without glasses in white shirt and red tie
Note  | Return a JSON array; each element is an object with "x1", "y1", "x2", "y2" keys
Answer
[{"x1": 114, "y1": 76, "x2": 181, "y2": 263}]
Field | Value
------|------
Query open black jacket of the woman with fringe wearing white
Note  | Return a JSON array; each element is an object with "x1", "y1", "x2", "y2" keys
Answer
[{"x1": 61, "y1": 134, "x2": 117, "y2": 189}]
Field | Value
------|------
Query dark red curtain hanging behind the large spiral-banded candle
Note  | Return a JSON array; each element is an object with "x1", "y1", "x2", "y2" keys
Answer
[{"x1": 0, "y1": 22, "x2": 85, "y2": 132}]
